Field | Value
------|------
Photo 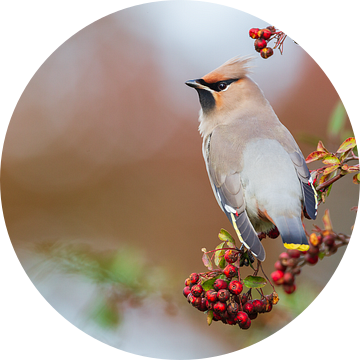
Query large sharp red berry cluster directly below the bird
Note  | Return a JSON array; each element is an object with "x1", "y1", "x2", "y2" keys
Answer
[{"x1": 183, "y1": 242, "x2": 279, "y2": 329}]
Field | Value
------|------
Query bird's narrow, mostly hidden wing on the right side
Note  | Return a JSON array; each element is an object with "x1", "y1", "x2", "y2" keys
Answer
[{"x1": 289, "y1": 150, "x2": 318, "y2": 220}]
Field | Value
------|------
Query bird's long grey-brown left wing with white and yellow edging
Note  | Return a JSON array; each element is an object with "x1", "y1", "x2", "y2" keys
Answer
[{"x1": 203, "y1": 130, "x2": 265, "y2": 261}]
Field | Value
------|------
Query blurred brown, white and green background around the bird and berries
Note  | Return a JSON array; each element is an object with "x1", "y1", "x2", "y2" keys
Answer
[{"x1": 0, "y1": 0, "x2": 359, "y2": 359}]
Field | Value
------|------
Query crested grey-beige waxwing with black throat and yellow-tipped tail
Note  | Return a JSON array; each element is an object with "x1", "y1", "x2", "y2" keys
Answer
[{"x1": 185, "y1": 56, "x2": 318, "y2": 261}]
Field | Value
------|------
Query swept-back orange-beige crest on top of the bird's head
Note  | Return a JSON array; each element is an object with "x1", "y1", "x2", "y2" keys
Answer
[{"x1": 203, "y1": 56, "x2": 255, "y2": 84}]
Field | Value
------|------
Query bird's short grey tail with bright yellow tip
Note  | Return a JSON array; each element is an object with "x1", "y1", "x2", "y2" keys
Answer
[{"x1": 273, "y1": 216, "x2": 309, "y2": 251}]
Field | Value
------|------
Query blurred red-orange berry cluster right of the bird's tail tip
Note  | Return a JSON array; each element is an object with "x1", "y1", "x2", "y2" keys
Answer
[{"x1": 271, "y1": 230, "x2": 347, "y2": 294}]
